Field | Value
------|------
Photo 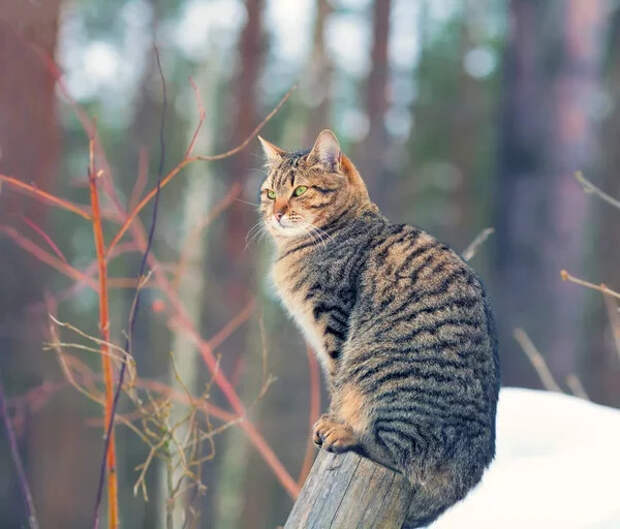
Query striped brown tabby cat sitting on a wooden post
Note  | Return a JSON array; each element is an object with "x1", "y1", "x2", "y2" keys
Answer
[{"x1": 259, "y1": 130, "x2": 499, "y2": 528}]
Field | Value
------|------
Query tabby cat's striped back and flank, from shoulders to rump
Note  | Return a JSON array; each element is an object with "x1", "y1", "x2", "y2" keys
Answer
[{"x1": 340, "y1": 221, "x2": 499, "y2": 503}]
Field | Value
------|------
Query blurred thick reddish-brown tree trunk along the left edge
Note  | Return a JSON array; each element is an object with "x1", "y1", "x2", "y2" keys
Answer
[{"x1": 0, "y1": 0, "x2": 62, "y2": 527}]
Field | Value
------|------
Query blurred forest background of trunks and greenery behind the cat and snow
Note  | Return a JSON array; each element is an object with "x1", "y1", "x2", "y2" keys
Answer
[{"x1": 0, "y1": 0, "x2": 620, "y2": 529}]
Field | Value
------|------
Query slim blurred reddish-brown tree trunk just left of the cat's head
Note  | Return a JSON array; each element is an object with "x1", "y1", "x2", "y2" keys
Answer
[{"x1": 211, "y1": 0, "x2": 265, "y2": 529}]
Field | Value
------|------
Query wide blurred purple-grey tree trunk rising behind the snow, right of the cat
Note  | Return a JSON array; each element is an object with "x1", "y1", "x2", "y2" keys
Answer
[{"x1": 495, "y1": 0, "x2": 604, "y2": 384}]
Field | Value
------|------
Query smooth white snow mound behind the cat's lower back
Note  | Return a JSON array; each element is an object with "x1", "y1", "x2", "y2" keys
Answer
[{"x1": 429, "y1": 388, "x2": 620, "y2": 529}]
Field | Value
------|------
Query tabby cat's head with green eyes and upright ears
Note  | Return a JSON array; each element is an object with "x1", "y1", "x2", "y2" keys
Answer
[{"x1": 259, "y1": 130, "x2": 370, "y2": 242}]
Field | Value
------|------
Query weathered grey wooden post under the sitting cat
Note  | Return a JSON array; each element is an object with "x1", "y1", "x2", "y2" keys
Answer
[{"x1": 284, "y1": 450, "x2": 411, "y2": 529}]
